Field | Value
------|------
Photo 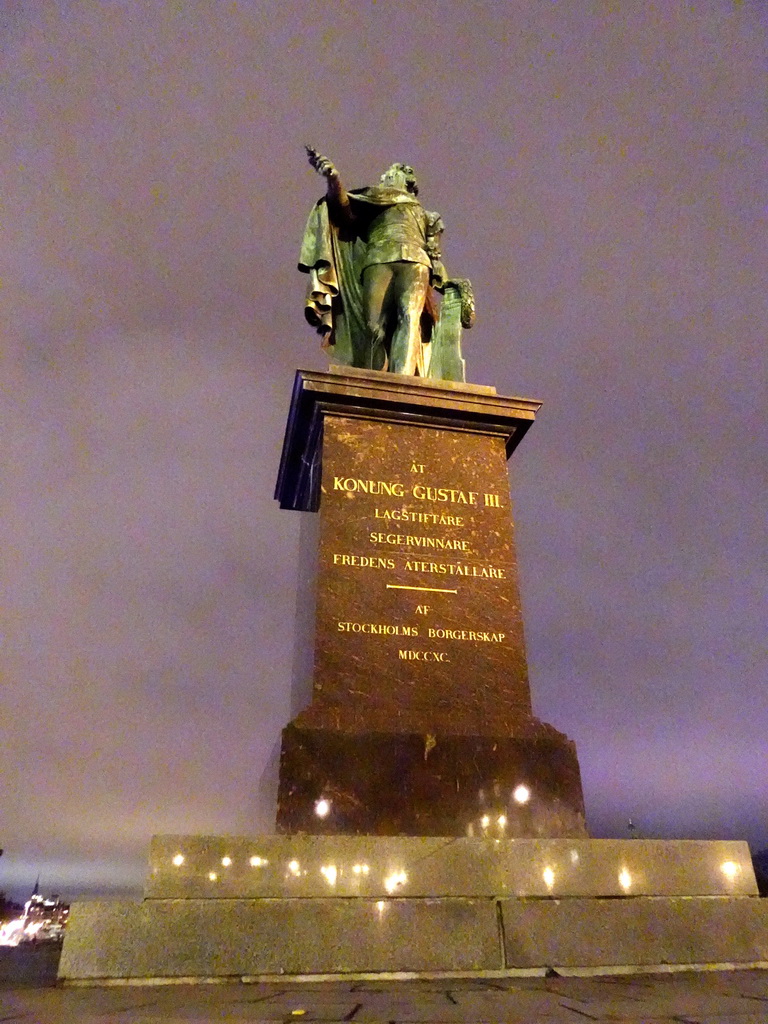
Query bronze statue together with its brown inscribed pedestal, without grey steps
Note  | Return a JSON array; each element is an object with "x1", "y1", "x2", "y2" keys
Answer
[{"x1": 275, "y1": 150, "x2": 586, "y2": 837}]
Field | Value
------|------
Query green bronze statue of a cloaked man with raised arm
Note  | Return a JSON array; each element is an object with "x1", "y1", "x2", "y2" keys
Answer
[{"x1": 299, "y1": 146, "x2": 474, "y2": 381}]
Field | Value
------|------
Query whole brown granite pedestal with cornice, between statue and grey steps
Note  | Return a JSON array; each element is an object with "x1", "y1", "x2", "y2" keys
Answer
[{"x1": 276, "y1": 369, "x2": 586, "y2": 837}]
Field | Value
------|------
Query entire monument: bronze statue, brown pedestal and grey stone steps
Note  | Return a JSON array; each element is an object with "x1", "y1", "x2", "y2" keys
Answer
[{"x1": 59, "y1": 151, "x2": 768, "y2": 983}]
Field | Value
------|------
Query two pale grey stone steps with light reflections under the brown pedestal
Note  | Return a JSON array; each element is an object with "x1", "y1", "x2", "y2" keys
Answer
[{"x1": 59, "y1": 836, "x2": 768, "y2": 984}]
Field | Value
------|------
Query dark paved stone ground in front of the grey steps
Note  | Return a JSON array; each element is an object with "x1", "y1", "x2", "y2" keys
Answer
[{"x1": 0, "y1": 971, "x2": 768, "y2": 1024}]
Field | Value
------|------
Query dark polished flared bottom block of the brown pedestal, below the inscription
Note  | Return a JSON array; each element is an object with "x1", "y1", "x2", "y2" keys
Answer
[{"x1": 276, "y1": 720, "x2": 587, "y2": 838}]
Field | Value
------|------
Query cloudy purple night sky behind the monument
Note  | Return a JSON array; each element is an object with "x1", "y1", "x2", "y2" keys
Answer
[{"x1": 0, "y1": 0, "x2": 768, "y2": 896}]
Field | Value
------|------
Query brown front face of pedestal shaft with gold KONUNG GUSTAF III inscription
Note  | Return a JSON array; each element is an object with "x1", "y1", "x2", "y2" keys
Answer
[{"x1": 297, "y1": 416, "x2": 531, "y2": 735}]
